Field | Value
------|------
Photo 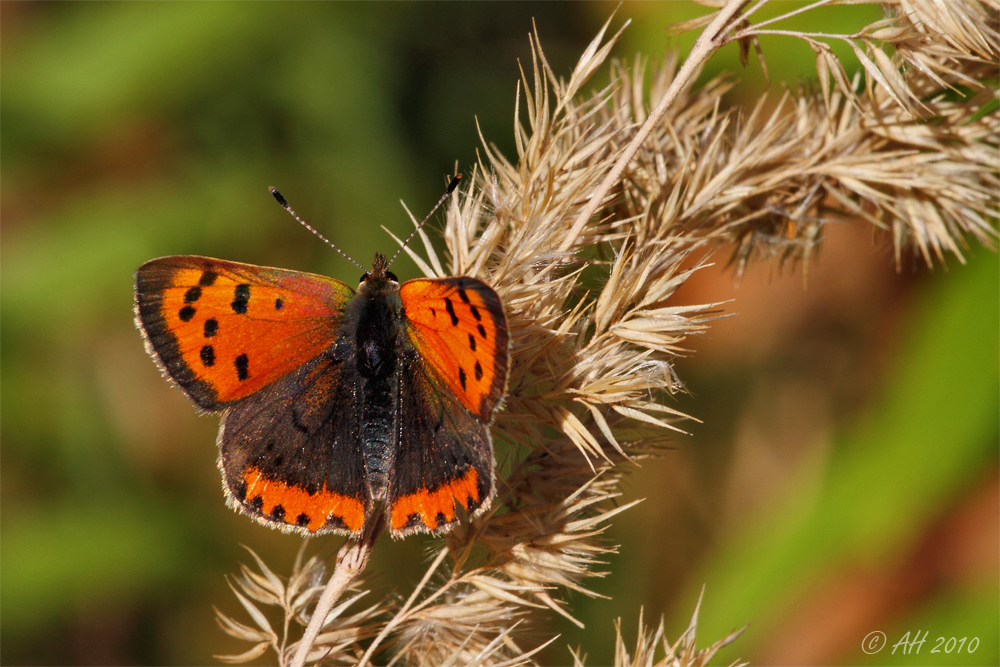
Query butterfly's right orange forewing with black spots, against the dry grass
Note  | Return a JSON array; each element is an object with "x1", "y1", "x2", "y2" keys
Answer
[{"x1": 399, "y1": 277, "x2": 509, "y2": 423}]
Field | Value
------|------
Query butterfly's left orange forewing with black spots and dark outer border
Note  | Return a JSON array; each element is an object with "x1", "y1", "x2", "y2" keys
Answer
[{"x1": 135, "y1": 256, "x2": 354, "y2": 411}]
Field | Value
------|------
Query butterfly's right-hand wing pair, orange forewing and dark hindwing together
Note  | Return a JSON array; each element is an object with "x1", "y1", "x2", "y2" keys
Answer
[{"x1": 388, "y1": 277, "x2": 508, "y2": 536}]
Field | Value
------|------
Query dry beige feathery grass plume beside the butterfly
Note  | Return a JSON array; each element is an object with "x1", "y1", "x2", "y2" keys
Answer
[{"x1": 220, "y1": 0, "x2": 1000, "y2": 665}]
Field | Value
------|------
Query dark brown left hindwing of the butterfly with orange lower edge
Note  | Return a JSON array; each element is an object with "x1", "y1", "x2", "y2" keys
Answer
[{"x1": 219, "y1": 346, "x2": 372, "y2": 535}]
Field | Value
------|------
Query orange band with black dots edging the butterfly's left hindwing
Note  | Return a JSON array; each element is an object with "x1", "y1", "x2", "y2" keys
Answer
[{"x1": 241, "y1": 468, "x2": 365, "y2": 533}]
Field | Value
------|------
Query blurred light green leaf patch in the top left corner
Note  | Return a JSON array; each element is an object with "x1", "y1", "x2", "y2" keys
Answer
[{"x1": 3, "y1": 2, "x2": 281, "y2": 142}]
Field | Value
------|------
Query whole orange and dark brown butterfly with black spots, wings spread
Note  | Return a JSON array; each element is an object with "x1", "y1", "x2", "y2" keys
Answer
[{"x1": 135, "y1": 179, "x2": 508, "y2": 537}]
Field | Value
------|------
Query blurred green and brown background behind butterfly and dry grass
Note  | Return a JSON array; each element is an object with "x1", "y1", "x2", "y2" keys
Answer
[{"x1": 0, "y1": 2, "x2": 1000, "y2": 665}]
